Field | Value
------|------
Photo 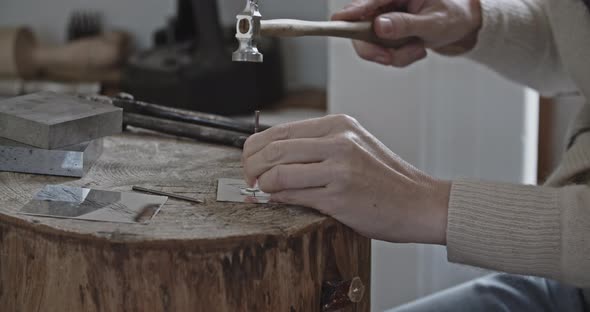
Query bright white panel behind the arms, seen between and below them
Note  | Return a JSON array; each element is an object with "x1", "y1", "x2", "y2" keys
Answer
[{"x1": 328, "y1": 0, "x2": 538, "y2": 311}]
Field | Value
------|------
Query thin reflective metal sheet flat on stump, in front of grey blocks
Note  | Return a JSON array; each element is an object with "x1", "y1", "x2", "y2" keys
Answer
[{"x1": 19, "y1": 185, "x2": 168, "y2": 223}]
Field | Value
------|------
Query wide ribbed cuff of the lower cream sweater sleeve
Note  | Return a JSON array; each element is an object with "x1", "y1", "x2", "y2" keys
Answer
[{"x1": 447, "y1": 180, "x2": 561, "y2": 277}]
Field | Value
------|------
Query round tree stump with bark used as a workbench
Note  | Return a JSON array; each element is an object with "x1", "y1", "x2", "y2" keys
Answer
[{"x1": 0, "y1": 132, "x2": 371, "y2": 312}]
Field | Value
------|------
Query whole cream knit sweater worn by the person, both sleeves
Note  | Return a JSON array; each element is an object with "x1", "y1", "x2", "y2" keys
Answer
[{"x1": 447, "y1": 0, "x2": 590, "y2": 288}]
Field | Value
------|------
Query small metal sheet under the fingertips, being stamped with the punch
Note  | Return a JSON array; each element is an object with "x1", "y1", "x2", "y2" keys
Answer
[{"x1": 217, "y1": 179, "x2": 270, "y2": 204}]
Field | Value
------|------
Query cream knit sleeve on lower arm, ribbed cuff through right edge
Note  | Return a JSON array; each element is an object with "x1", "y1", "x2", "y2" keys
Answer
[{"x1": 447, "y1": 180, "x2": 590, "y2": 287}]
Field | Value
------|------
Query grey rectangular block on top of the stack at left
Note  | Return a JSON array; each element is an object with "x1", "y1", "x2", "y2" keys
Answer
[{"x1": 0, "y1": 92, "x2": 123, "y2": 149}]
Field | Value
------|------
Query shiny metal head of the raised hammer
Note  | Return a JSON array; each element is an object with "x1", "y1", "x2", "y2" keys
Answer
[{"x1": 232, "y1": 0, "x2": 264, "y2": 63}]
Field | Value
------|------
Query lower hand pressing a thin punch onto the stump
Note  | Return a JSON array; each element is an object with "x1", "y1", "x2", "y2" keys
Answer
[{"x1": 242, "y1": 115, "x2": 450, "y2": 244}]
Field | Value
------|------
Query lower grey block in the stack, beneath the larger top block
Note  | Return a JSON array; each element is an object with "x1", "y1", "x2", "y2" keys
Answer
[{"x1": 0, "y1": 138, "x2": 103, "y2": 178}]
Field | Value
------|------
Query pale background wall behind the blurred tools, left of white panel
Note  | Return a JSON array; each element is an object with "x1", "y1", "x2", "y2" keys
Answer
[{"x1": 0, "y1": 0, "x2": 327, "y2": 88}]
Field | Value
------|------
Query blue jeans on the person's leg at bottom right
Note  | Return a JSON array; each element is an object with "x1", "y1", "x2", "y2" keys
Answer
[{"x1": 389, "y1": 274, "x2": 588, "y2": 312}]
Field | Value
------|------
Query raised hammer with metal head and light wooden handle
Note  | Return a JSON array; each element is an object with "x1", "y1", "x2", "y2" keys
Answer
[{"x1": 232, "y1": 0, "x2": 415, "y2": 63}]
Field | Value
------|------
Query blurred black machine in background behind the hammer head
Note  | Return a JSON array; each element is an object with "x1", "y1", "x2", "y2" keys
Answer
[{"x1": 122, "y1": 0, "x2": 285, "y2": 115}]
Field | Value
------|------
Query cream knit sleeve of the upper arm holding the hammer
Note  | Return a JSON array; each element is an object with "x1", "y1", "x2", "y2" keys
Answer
[{"x1": 464, "y1": 0, "x2": 576, "y2": 95}]
